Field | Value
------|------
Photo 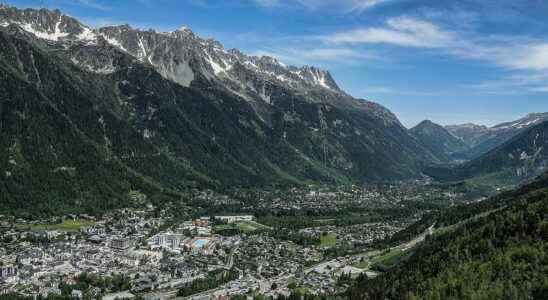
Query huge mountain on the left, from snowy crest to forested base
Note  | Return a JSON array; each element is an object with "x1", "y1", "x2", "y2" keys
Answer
[{"x1": 0, "y1": 5, "x2": 439, "y2": 213}]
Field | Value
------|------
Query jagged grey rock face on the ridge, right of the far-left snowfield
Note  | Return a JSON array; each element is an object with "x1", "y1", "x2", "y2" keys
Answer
[{"x1": 98, "y1": 25, "x2": 343, "y2": 110}]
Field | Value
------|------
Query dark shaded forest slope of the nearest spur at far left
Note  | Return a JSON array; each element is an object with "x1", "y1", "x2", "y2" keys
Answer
[{"x1": 0, "y1": 33, "x2": 188, "y2": 214}]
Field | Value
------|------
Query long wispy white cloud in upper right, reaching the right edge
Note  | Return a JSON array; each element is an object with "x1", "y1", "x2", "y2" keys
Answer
[{"x1": 323, "y1": 16, "x2": 548, "y2": 70}]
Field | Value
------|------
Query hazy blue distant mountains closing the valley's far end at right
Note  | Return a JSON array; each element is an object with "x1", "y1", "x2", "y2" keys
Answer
[{"x1": 409, "y1": 113, "x2": 548, "y2": 185}]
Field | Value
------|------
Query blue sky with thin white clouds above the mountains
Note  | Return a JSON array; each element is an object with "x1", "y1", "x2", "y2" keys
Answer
[{"x1": 3, "y1": 0, "x2": 548, "y2": 126}]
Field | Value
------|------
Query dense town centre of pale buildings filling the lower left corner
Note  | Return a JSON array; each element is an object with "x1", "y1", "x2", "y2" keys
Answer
[{"x1": 0, "y1": 208, "x2": 264, "y2": 299}]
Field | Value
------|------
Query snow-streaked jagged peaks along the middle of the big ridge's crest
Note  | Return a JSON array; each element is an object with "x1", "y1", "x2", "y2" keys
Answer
[{"x1": 92, "y1": 21, "x2": 340, "y2": 93}]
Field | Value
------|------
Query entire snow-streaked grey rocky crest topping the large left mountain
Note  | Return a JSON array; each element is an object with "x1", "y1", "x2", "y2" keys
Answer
[{"x1": 0, "y1": 6, "x2": 342, "y2": 102}]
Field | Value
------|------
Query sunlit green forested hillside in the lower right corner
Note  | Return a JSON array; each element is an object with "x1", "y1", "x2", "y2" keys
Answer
[{"x1": 348, "y1": 172, "x2": 548, "y2": 299}]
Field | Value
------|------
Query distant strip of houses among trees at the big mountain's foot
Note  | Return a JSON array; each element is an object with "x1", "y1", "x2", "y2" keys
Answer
[{"x1": 191, "y1": 182, "x2": 469, "y2": 214}]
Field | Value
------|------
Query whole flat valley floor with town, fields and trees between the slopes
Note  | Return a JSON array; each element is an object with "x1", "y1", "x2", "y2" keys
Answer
[{"x1": 0, "y1": 183, "x2": 504, "y2": 299}]
